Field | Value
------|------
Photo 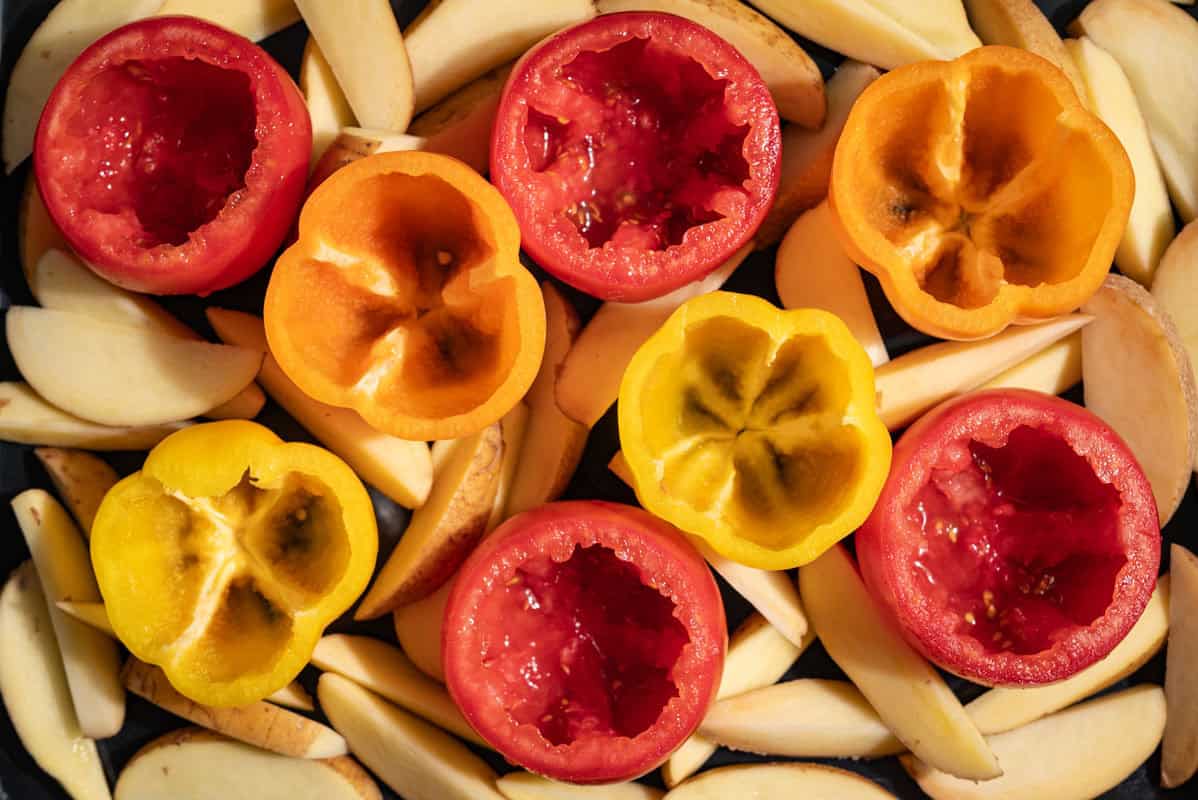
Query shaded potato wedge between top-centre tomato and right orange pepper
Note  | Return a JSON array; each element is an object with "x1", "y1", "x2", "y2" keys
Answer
[{"x1": 754, "y1": 61, "x2": 882, "y2": 249}]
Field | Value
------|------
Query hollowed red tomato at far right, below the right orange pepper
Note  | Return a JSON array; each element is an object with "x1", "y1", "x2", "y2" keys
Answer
[{"x1": 857, "y1": 389, "x2": 1161, "y2": 685}]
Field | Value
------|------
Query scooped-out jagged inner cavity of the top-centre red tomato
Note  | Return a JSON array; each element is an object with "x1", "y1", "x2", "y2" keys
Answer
[{"x1": 524, "y1": 36, "x2": 751, "y2": 250}]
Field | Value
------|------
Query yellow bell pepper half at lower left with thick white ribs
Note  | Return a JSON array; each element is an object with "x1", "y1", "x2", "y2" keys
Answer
[{"x1": 91, "y1": 420, "x2": 379, "y2": 705}]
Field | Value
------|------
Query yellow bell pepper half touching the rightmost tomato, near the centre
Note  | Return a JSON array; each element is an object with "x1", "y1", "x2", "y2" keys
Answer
[{"x1": 619, "y1": 292, "x2": 890, "y2": 570}]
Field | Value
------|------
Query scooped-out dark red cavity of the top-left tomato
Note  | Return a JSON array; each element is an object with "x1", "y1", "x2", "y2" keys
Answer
[{"x1": 62, "y1": 57, "x2": 258, "y2": 248}]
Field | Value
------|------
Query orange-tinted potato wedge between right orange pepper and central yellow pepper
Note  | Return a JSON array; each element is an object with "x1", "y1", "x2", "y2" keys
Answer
[{"x1": 774, "y1": 200, "x2": 890, "y2": 366}]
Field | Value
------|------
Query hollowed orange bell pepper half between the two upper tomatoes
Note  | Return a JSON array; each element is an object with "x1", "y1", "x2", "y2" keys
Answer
[{"x1": 264, "y1": 152, "x2": 545, "y2": 440}]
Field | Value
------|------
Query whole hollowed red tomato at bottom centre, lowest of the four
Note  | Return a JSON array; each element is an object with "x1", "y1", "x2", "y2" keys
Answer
[{"x1": 442, "y1": 502, "x2": 727, "y2": 783}]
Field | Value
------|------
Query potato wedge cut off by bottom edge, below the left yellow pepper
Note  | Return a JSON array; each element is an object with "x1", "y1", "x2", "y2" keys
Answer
[{"x1": 116, "y1": 728, "x2": 382, "y2": 800}]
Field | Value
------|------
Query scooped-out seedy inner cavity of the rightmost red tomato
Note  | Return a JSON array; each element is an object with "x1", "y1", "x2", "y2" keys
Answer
[{"x1": 912, "y1": 426, "x2": 1127, "y2": 654}]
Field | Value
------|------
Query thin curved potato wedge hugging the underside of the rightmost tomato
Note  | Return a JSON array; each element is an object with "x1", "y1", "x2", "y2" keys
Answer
[{"x1": 966, "y1": 575, "x2": 1170, "y2": 737}]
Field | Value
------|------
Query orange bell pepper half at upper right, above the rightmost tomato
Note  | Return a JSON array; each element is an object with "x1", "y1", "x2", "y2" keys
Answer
[{"x1": 829, "y1": 47, "x2": 1135, "y2": 339}]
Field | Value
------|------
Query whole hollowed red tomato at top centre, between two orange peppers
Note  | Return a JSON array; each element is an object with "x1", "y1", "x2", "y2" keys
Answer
[{"x1": 491, "y1": 12, "x2": 782, "y2": 302}]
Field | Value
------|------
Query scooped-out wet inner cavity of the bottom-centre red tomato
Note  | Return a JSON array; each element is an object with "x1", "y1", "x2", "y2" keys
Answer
[{"x1": 479, "y1": 545, "x2": 689, "y2": 745}]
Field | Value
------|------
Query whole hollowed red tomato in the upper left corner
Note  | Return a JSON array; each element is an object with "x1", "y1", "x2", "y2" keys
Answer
[{"x1": 34, "y1": 17, "x2": 311, "y2": 295}]
